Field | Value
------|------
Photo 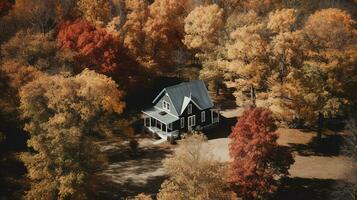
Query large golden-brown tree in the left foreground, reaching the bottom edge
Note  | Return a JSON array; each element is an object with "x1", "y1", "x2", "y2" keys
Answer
[{"x1": 20, "y1": 69, "x2": 124, "y2": 199}]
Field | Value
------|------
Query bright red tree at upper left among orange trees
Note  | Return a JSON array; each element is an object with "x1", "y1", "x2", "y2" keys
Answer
[{"x1": 58, "y1": 19, "x2": 122, "y2": 73}]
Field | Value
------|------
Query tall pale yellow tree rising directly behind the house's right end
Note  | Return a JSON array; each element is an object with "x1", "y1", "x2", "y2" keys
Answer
[{"x1": 184, "y1": 5, "x2": 224, "y2": 94}]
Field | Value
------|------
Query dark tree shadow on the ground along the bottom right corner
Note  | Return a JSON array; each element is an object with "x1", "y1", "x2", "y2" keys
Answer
[{"x1": 271, "y1": 177, "x2": 352, "y2": 200}]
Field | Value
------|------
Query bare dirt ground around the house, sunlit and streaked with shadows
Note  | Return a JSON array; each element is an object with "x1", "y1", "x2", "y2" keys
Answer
[{"x1": 98, "y1": 113, "x2": 357, "y2": 200}]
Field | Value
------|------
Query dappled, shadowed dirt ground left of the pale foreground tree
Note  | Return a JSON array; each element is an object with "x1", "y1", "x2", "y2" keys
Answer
[{"x1": 96, "y1": 143, "x2": 172, "y2": 200}]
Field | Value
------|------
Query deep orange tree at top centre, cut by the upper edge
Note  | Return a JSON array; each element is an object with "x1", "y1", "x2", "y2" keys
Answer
[{"x1": 118, "y1": 0, "x2": 192, "y2": 71}]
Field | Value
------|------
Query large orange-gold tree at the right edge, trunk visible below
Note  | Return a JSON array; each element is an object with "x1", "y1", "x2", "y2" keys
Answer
[{"x1": 289, "y1": 9, "x2": 357, "y2": 138}]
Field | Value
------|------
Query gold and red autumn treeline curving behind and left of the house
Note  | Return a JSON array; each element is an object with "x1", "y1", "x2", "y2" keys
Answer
[{"x1": 0, "y1": 0, "x2": 357, "y2": 199}]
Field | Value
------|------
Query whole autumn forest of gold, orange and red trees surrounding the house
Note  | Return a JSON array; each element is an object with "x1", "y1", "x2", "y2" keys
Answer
[{"x1": 0, "y1": 0, "x2": 357, "y2": 200}]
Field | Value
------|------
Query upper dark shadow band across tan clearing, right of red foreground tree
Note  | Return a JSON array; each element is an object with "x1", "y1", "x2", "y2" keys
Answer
[{"x1": 289, "y1": 134, "x2": 343, "y2": 156}]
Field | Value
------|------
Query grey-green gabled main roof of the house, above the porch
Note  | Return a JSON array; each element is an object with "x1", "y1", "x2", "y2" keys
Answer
[{"x1": 153, "y1": 80, "x2": 213, "y2": 114}]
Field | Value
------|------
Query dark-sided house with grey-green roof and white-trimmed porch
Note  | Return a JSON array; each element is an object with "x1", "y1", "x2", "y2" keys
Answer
[{"x1": 142, "y1": 80, "x2": 219, "y2": 139}]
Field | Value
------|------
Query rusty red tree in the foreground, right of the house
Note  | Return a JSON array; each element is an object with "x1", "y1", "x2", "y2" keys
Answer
[{"x1": 229, "y1": 108, "x2": 294, "y2": 199}]
